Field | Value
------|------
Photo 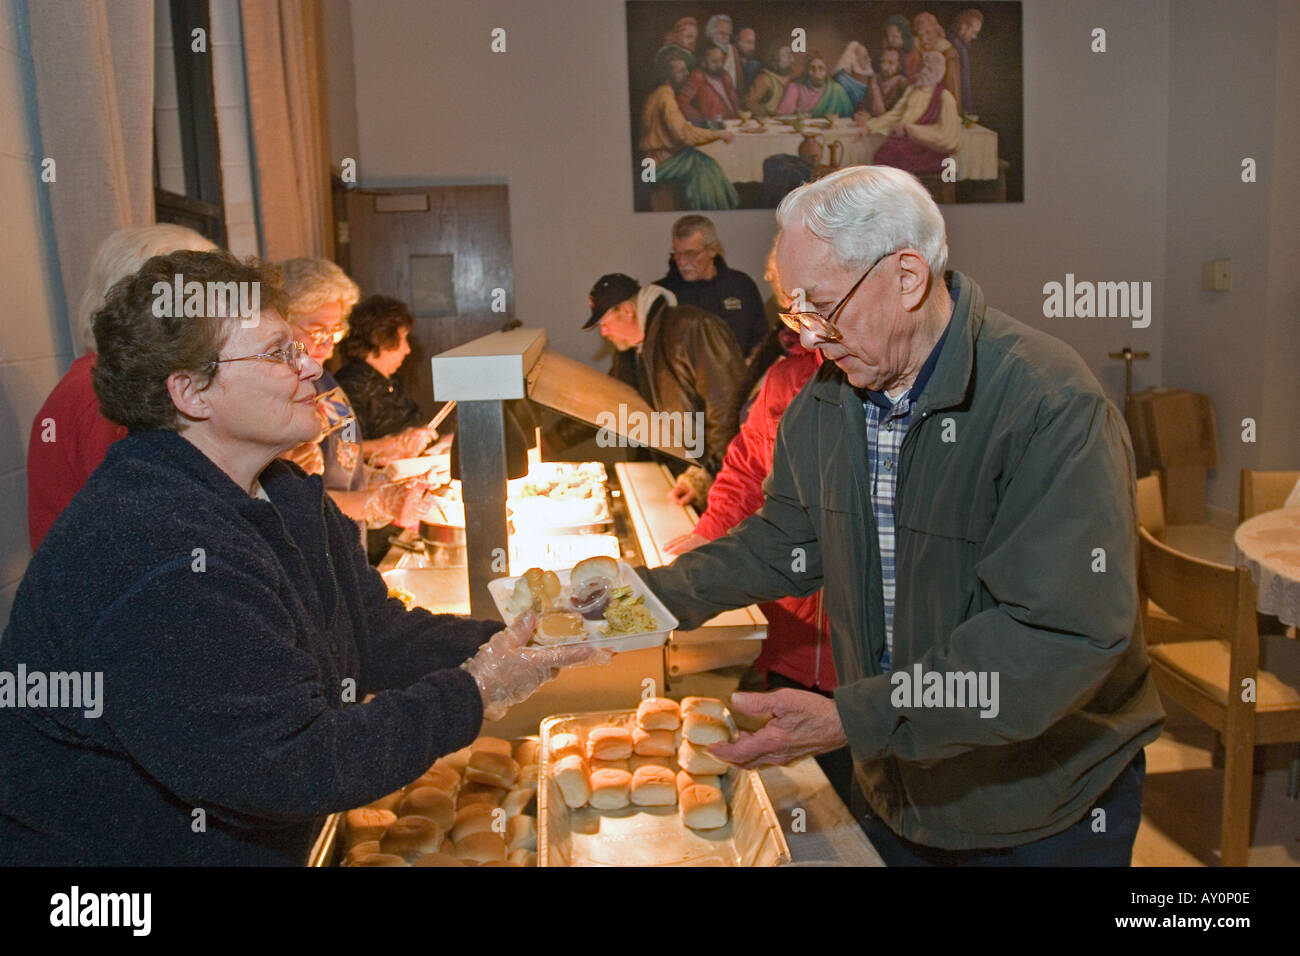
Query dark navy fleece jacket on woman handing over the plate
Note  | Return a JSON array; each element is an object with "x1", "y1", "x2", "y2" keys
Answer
[{"x1": 0, "y1": 432, "x2": 501, "y2": 865}]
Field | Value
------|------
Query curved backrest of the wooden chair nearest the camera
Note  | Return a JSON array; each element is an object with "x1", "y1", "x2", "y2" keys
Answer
[{"x1": 1138, "y1": 527, "x2": 1260, "y2": 680}]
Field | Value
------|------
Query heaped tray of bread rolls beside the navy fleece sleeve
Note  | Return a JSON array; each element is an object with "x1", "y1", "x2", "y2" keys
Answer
[{"x1": 317, "y1": 736, "x2": 541, "y2": 866}]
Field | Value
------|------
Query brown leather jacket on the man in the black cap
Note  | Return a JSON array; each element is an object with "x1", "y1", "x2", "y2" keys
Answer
[{"x1": 626, "y1": 297, "x2": 748, "y2": 475}]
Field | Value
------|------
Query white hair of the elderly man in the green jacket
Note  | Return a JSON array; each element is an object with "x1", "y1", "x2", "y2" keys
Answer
[{"x1": 776, "y1": 166, "x2": 948, "y2": 282}]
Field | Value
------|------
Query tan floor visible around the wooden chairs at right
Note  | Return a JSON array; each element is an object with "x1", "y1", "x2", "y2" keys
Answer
[{"x1": 1134, "y1": 524, "x2": 1300, "y2": 866}]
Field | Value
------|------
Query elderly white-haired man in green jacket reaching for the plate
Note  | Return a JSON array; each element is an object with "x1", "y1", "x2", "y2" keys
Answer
[{"x1": 642, "y1": 166, "x2": 1164, "y2": 865}]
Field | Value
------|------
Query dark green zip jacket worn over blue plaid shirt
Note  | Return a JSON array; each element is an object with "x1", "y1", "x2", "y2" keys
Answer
[{"x1": 641, "y1": 272, "x2": 1165, "y2": 849}]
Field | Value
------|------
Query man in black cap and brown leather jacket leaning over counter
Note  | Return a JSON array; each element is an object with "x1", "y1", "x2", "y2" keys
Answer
[{"x1": 582, "y1": 273, "x2": 746, "y2": 506}]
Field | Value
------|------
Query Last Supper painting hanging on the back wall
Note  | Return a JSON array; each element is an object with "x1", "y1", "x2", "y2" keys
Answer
[{"x1": 627, "y1": 0, "x2": 1024, "y2": 212}]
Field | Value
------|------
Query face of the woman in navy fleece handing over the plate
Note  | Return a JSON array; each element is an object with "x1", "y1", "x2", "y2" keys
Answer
[{"x1": 204, "y1": 311, "x2": 321, "y2": 455}]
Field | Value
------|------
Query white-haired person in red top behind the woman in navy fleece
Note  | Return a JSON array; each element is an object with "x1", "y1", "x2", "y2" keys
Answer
[{"x1": 27, "y1": 222, "x2": 216, "y2": 553}]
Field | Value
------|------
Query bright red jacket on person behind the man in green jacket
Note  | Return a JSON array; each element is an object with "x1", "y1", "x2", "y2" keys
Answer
[{"x1": 696, "y1": 350, "x2": 836, "y2": 691}]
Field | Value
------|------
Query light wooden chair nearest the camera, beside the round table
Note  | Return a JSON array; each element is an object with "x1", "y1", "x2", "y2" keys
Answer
[{"x1": 1138, "y1": 528, "x2": 1300, "y2": 866}]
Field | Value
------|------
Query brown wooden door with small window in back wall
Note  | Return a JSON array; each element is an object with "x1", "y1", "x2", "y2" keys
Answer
[{"x1": 338, "y1": 186, "x2": 515, "y2": 416}]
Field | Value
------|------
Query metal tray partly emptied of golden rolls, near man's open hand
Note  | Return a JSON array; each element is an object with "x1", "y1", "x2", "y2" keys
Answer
[{"x1": 537, "y1": 697, "x2": 790, "y2": 866}]
